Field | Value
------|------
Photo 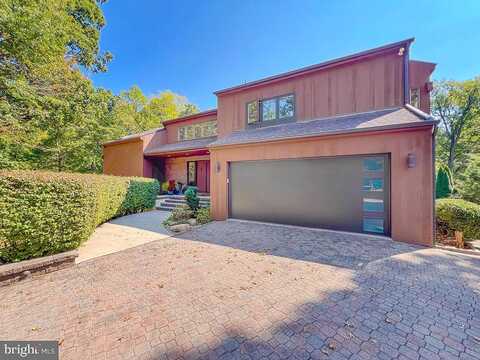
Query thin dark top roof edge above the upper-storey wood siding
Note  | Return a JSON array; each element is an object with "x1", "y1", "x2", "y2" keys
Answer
[{"x1": 214, "y1": 38, "x2": 415, "y2": 95}]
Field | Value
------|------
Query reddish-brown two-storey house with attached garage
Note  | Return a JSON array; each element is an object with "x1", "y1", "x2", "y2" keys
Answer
[{"x1": 104, "y1": 39, "x2": 436, "y2": 245}]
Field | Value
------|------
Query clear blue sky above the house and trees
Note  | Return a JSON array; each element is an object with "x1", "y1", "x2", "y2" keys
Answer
[{"x1": 92, "y1": 0, "x2": 480, "y2": 110}]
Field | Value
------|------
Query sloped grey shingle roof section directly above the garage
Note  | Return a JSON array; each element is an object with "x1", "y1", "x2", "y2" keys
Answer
[{"x1": 209, "y1": 105, "x2": 437, "y2": 147}]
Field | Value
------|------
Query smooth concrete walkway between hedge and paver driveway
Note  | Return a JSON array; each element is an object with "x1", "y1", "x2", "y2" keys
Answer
[{"x1": 76, "y1": 210, "x2": 171, "y2": 263}]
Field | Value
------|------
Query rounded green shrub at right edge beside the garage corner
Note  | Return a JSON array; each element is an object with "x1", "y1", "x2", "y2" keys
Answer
[{"x1": 436, "y1": 199, "x2": 480, "y2": 239}]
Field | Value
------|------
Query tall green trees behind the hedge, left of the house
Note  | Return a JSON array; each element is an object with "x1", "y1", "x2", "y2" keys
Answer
[{"x1": 0, "y1": 0, "x2": 197, "y2": 173}]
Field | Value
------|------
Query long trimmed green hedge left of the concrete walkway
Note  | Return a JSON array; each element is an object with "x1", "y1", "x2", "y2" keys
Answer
[{"x1": 0, "y1": 171, "x2": 160, "y2": 262}]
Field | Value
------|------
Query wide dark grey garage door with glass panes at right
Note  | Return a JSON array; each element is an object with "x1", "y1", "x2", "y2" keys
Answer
[{"x1": 229, "y1": 154, "x2": 390, "y2": 235}]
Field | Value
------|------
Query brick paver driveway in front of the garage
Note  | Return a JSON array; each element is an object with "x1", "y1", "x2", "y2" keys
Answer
[{"x1": 0, "y1": 222, "x2": 480, "y2": 360}]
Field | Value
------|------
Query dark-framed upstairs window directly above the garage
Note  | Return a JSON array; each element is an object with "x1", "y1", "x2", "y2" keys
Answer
[{"x1": 246, "y1": 94, "x2": 295, "y2": 125}]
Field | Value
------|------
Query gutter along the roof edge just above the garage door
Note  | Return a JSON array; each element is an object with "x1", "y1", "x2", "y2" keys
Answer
[{"x1": 207, "y1": 118, "x2": 438, "y2": 149}]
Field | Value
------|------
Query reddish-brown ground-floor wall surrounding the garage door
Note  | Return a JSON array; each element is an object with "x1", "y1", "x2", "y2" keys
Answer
[{"x1": 210, "y1": 126, "x2": 433, "y2": 245}]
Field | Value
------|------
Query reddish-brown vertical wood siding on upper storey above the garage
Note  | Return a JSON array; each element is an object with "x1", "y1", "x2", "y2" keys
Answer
[{"x1": 218, "y1": 50, "x2": 403, "y2": 137}]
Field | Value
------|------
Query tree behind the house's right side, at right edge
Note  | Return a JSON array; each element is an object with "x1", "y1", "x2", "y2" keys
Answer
[{"x1": 432, "y1": 78, "x2": 480, "y2": 174}]
